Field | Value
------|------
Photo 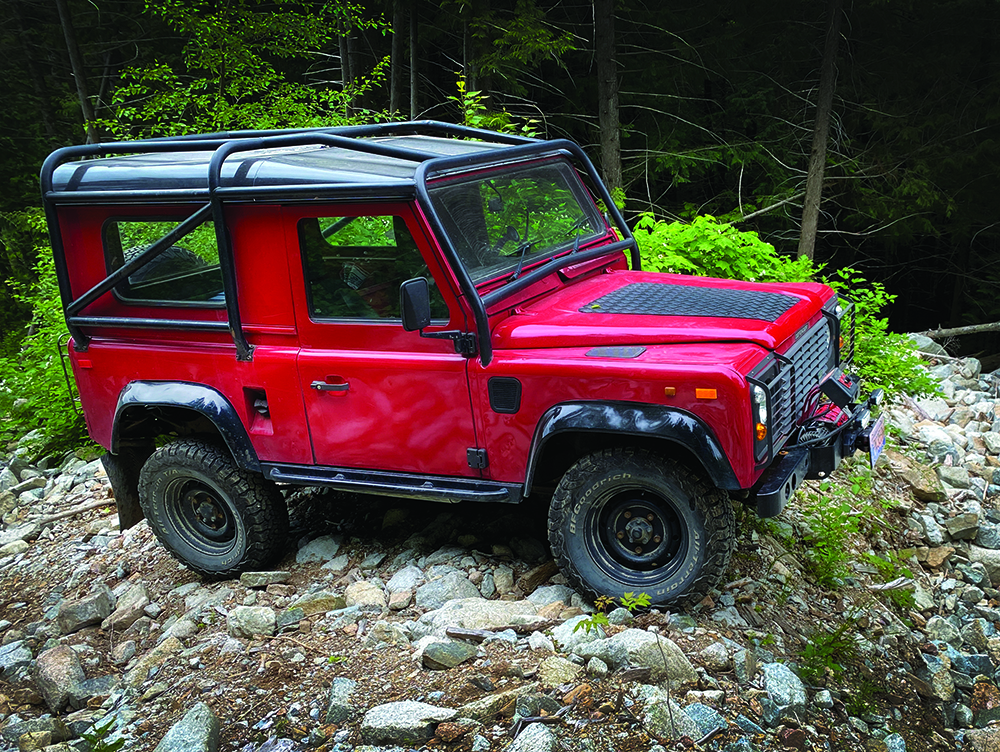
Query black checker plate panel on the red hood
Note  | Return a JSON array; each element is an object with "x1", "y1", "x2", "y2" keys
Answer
[{"x1": 580, "y1": 282, "x2": 799, "y2": 322}]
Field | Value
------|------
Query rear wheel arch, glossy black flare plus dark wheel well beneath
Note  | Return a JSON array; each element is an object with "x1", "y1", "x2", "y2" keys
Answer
[{"x1": 110, "y1": 381, "x2": 261, "y2": 472}]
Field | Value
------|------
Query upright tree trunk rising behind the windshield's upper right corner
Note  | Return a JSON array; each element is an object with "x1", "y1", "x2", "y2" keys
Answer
[{"x1": 594, "y1": 0, "x2": 622, "y2": 197}]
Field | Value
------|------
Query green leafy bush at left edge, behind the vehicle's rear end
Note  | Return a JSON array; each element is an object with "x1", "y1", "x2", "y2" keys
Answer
[{"x1": 0, "y1": 212, "x2": 85, "y2": 450}]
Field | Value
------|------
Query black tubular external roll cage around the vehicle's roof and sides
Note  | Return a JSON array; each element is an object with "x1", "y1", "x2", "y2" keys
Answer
[{"x1": 41, "y1": 120, "x2": 639, "y2": 365}]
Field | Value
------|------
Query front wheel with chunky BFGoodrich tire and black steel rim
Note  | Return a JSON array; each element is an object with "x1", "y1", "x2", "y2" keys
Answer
[{"x1": 549, "y1": 448, "x2": 736, "y2": 606}]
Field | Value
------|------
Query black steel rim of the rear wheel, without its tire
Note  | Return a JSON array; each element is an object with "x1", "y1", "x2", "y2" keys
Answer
[{"x1": 165, "y1": 478, "x2": 240, "y2": 556}]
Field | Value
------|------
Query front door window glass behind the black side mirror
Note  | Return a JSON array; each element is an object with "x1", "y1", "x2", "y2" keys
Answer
[{"x1": 298, "y1": 215, "x2": 448, "y2": 320}]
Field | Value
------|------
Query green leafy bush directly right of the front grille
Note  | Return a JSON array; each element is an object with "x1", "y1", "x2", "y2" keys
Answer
[{"x1": 826, "y1": 269, "x2": 937, "y2": 395}]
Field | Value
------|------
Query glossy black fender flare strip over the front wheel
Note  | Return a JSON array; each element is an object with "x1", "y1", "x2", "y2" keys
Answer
[{"x1": 524, "y1": 402, "x2": 741, "y2": 496}]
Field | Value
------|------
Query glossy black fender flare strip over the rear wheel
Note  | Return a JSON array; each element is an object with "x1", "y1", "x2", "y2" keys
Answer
[{"x1": 111, "y1": 381, "x2": 261, "y2": 473}]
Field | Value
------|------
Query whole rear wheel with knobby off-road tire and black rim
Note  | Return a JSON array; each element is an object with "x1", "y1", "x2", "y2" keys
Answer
[{"x1": 139, "y1": 439, "x2": 288, "y2": 578}]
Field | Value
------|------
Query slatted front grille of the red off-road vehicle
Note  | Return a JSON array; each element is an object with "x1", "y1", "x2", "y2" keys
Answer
[{"x1": 767, "y1": 318, "x2": 836, "y2": 447}]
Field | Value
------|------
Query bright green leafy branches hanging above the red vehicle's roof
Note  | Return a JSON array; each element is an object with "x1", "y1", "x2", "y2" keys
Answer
[{"x1": 100, "y1": 0, "x2": 388, "y2": 138}]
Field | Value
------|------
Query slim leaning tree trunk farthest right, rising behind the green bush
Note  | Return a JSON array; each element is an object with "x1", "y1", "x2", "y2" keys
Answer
[{"x1": 798, "y1": 0, "x2": 843, "y2": 259}]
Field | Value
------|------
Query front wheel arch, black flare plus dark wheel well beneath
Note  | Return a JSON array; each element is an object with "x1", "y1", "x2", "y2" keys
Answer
[{"x1": 524, "y1": 402, "x2": 741, "y2": 496}]
